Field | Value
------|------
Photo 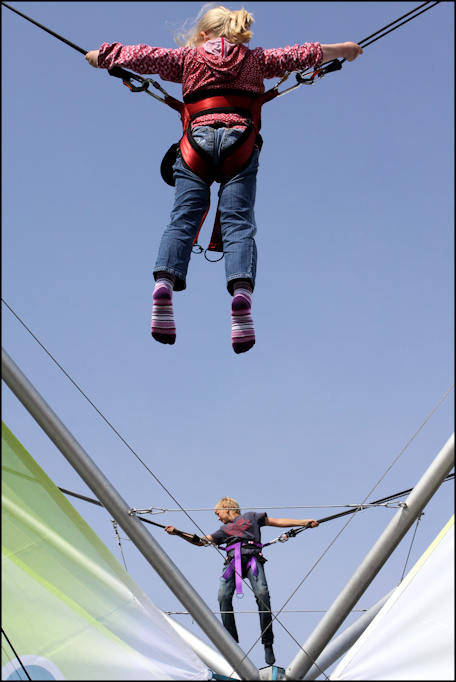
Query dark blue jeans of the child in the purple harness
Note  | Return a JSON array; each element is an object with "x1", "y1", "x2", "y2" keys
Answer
[{"x1": 219, "y1": 561, "x2": 274, "y2": 646}]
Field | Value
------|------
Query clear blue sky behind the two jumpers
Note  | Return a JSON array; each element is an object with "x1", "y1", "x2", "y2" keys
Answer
[{"x1": 2, "y1": 2, "x2": 454, "y2": 667}]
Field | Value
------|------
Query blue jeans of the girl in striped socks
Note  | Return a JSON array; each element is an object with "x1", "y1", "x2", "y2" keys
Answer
[{"x1": 154, "y1": 126, "x2": 259, "y2": 293}]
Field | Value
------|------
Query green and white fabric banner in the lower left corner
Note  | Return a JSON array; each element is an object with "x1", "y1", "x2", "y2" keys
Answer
[{"x1": 2, "y1": 424, "x2": 210, "y2": 680}]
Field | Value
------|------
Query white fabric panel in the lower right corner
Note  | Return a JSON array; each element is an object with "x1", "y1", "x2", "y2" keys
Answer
[{"x1": 330, "y1": 517, "x2": 454, "y2": 680}]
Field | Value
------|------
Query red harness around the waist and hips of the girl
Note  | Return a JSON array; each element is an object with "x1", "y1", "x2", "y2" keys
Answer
[{"x1": 162, "y1": 89, "x2": 278, "y2": 252}]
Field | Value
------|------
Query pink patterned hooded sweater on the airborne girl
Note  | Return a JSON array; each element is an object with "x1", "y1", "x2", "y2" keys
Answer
[{"x1": 98, "y1": 38, "x2": 323, "y2": 127}]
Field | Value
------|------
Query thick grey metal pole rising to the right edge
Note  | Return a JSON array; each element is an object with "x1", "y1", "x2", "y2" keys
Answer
[{"x1": 285, "y1": 433, "x2": 454, "y2": 680}]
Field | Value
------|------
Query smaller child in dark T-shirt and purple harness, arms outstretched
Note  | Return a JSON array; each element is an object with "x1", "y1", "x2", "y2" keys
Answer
[{"x1": 165, "y1": 497, "x2": 318, "y2": 665}]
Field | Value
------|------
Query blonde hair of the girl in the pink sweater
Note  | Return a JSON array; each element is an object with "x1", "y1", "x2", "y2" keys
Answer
[{"x1": 175, "y1": 4, "x2": 254, "y2": 47}]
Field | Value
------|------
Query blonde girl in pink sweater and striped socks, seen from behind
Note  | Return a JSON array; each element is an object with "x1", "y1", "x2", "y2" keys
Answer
[{"x1": 86, "y1": 6, "x2": 363, "y2": 353}]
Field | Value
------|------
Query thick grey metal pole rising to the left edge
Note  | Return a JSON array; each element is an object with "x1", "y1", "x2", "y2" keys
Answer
[{"x1": 2, "y1": 348, "x2": 259, "y2": 680}]
